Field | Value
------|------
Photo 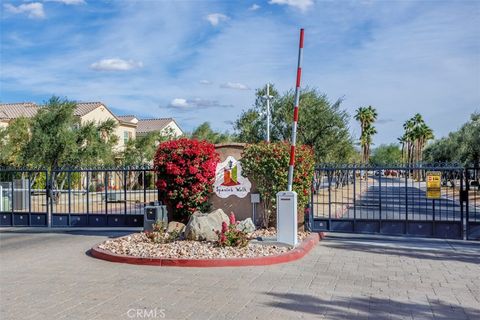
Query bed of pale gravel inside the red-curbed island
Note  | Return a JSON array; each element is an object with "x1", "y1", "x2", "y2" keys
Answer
[{"x1": 99, "y1": 229, "x2": 314, "y2": 259}]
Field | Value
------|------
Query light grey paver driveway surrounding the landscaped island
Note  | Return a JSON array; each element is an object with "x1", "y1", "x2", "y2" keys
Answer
[{"x1": 0, "y1": 230, "x2": 480, "y2": 320}]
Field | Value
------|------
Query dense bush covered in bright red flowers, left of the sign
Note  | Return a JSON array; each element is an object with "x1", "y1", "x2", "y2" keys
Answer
[{"x1": 154, "y1": 138, "x2": 219, "y2": 220}]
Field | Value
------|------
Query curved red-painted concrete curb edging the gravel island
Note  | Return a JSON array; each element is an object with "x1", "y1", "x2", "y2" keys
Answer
[{"x1": 90, "y1": 232, "x2": 325, "y2": 268}]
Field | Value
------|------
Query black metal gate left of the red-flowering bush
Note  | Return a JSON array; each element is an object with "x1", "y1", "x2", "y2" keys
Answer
[{"x1": 0, "y1": 167, "x2": 158, "y2": 227}]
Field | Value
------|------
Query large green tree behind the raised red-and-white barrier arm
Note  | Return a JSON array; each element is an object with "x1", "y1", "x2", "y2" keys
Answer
[{"x1": 234, "y1": 85, "x2": 355, "y2": 162}]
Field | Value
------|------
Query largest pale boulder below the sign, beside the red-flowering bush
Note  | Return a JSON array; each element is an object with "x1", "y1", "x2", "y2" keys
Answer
[{"x1": 185, "y1": 209, "x2": 229, "y2": 241}]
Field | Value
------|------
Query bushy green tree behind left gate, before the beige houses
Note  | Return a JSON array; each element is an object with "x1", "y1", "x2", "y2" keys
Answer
[{"x1": 23, "y1": 97, "x2": 118, "y2": 170}]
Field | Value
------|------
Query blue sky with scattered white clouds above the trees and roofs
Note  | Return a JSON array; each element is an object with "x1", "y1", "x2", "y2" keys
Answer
[{"x1": 0, "y1": 0, "x2": 480, "y2": 145}]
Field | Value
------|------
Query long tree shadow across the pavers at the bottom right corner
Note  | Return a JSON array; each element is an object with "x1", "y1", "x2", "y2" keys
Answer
[{"x1": 265, "y1": 292, "x2": 480, "y2": 320}]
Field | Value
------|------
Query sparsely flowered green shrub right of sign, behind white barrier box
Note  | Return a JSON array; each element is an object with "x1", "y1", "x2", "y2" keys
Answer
[{"x1": 241, "y1": 142, "x2": 315, "y2": 227}]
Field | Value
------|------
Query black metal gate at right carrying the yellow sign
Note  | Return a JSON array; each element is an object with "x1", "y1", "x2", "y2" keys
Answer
[{"x1": 309, "y1": 165, "x2": 480, "y2": 239}]
